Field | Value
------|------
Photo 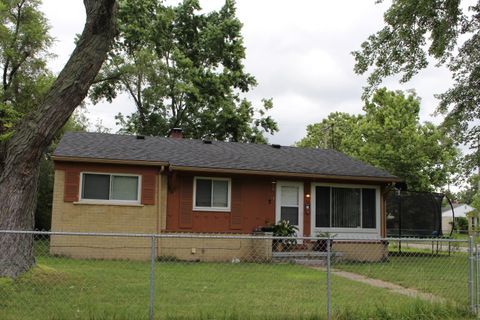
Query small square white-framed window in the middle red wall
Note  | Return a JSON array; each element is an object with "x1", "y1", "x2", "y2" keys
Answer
[{"x1": 193, "y1": 177, "x2": 231, "y2": 211}]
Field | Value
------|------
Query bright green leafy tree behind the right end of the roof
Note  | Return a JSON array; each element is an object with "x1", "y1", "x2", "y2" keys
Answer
[{"x1": 298, "y1": 89, "x2": 458, "y2": 190}]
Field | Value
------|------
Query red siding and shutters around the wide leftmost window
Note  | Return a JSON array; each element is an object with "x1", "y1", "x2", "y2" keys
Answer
[{"x1": 55, "y1": 161, "x2": 159, "y2": 205}]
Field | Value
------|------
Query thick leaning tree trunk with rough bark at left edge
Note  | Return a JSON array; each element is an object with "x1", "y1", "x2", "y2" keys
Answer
[{"x1": 0, "y1": 0, "x2": 117, "y2": 277}]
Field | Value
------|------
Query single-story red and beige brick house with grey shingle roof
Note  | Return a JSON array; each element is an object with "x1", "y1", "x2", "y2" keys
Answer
[{"x1": 51, "y1": 130, "x2": 399, "y2": 260}]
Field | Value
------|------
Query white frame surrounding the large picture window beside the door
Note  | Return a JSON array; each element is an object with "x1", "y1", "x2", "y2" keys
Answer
[{"x1": 310, "y1": 183, "x2": 381, "y2": 237}]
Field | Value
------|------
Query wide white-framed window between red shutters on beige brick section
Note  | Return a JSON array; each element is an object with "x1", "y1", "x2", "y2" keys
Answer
[{"x1": 81, "y1": 173, "x2": 140, "y2": 202}]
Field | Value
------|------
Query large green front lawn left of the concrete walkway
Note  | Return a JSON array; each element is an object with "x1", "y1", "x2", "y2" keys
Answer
[{"x1": 0, "y1": 248, "x2": 469, "y2": 320}]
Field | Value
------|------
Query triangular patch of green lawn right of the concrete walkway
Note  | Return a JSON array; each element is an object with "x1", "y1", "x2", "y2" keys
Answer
[{"x1": 334, "y1": 248, "x2": 468, "y2": 305}]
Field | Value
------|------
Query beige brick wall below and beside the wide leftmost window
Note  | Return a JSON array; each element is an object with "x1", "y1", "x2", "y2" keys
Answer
[{"x1": 50, "y1": 170, "x2": 162, "y2": 259}]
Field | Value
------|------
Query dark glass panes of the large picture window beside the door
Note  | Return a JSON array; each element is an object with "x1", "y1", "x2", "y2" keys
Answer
[{"x1": 315, "y1": 186, "x2": 377, "y2": 229}]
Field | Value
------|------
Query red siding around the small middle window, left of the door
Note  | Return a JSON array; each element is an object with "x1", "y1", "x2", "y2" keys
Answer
[{"x1": 167, "y1": 172, "x2": 275, "y2": 233}]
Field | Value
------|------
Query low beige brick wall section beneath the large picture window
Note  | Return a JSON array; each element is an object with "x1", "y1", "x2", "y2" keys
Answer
[{"x1": 332, "y1": 240, "x2": 388, "y2": 262}]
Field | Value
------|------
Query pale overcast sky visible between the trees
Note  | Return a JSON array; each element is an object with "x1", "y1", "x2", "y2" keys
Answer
[{"x1": 43, "y1": 0, "x2": 451, "y2": 145}]
